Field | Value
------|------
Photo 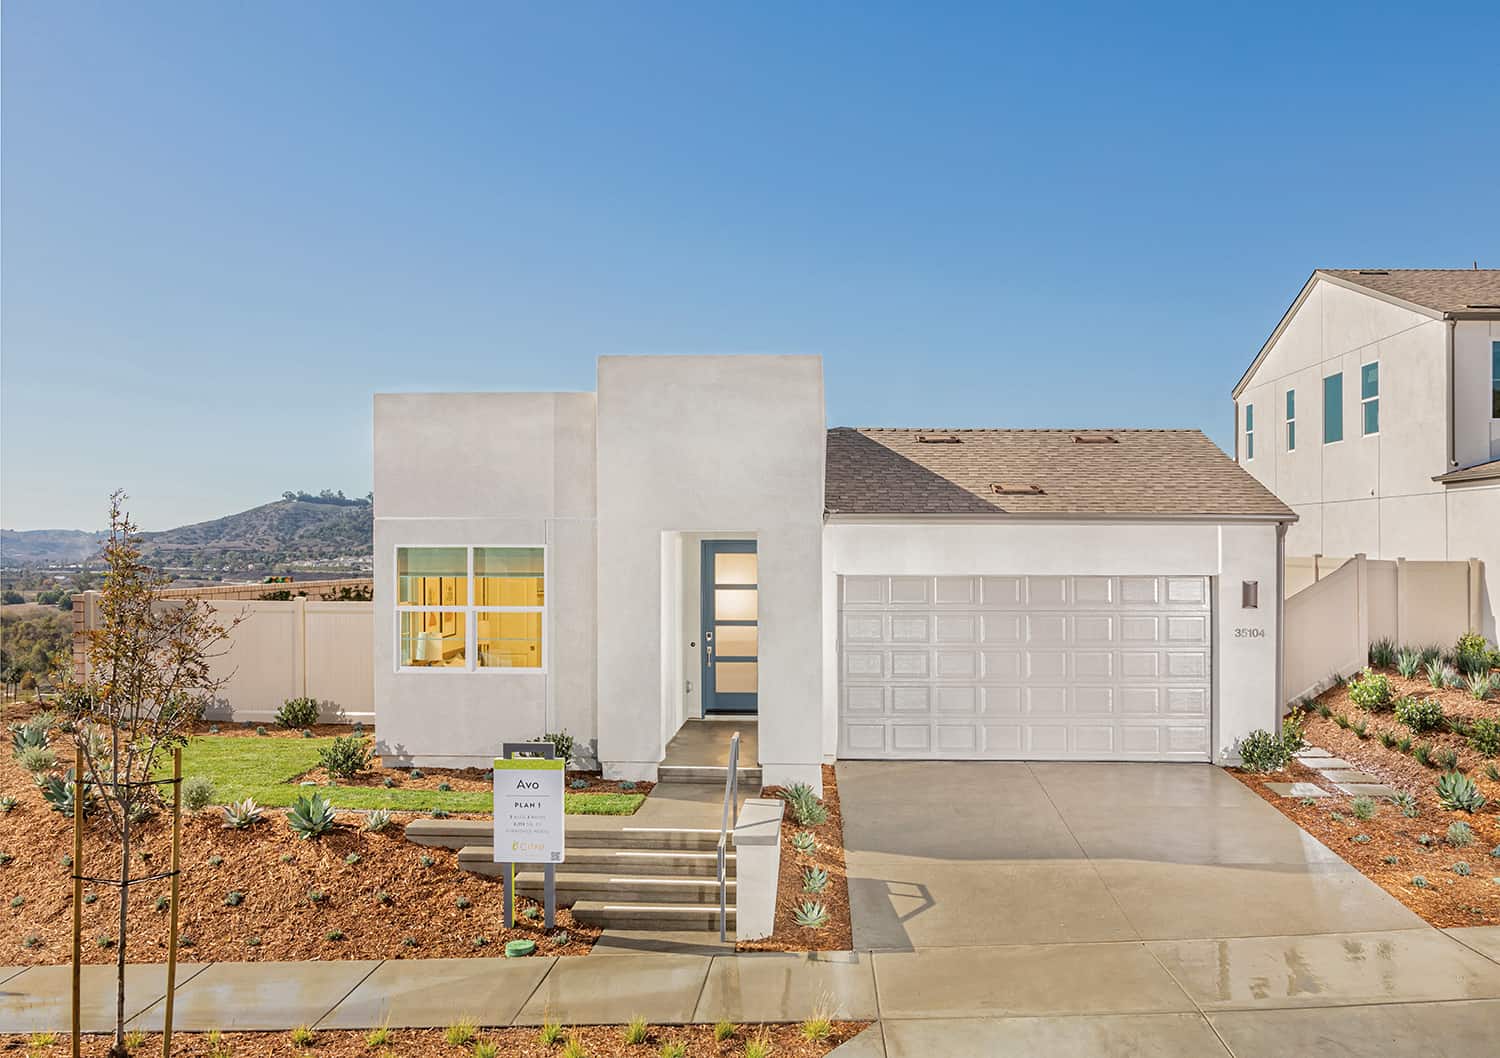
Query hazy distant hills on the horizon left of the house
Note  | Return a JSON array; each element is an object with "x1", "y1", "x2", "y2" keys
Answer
[{"x1": 0, "y1": 494, "x2": 374, "y2": 570}]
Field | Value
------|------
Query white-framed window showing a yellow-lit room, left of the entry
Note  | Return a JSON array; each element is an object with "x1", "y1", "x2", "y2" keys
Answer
[{"x1": 395, "y1": 546, "x2": 546, "y2": 672}]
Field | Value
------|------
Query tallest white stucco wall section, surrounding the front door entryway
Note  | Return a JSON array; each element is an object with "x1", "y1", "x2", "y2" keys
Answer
[{"x1": 594, "y1": 356, "x2": 827, "y2": 783}]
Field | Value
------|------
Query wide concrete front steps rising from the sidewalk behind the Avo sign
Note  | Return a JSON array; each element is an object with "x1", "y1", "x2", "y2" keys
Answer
[{"x1": 407, "y1": 816, "x2": 735, "y2": 930}]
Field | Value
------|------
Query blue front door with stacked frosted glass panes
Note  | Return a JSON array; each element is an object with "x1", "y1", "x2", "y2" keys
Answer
[{"x1": 701, "y1": 540, "x2": 761, "y2": 714}]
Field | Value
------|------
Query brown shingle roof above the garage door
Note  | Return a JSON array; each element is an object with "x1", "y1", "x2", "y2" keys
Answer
[{"x1": 824, "y1": 428, "x2": 1296, "y2": 521}]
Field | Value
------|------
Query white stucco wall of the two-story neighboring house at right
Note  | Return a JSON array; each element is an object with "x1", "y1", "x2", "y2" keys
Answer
[{"x1": 1235, "y1": 281, "x2": 1500, "y2": 638}]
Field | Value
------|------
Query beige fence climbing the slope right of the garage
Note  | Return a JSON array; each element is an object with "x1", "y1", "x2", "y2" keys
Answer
[{"x1": 1286, "y1": 555, "x2": 1484, "y2": 702}]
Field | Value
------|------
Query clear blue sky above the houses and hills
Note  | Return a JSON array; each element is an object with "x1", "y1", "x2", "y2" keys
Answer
[{"x1": 0, "y1": 2, "x2": 1500, "y2": 528}]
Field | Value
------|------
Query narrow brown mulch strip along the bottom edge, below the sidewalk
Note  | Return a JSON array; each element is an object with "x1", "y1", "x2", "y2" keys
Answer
[{"x1": 0, "y1": 1022, "x2": 869, "y2": 1058}]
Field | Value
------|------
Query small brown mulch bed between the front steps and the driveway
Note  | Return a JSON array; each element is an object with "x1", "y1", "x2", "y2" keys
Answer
[{"x1": 735, "y1": 764, "x2": 854, "y2": 948}]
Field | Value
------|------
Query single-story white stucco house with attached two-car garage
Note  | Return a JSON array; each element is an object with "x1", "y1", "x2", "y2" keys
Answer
[{"x1": 375, "y1": 356, "x2": 1296, "y2": 785}]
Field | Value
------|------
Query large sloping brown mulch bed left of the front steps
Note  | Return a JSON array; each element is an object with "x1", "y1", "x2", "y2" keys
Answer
[{"x1": 0, "y1": 752, "x2": 599, "y2": 963}]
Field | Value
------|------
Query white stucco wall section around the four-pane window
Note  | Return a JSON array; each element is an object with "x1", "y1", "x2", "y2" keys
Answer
[{"x1": 374, "y1": 393, "x2": 597, "y2": 767}]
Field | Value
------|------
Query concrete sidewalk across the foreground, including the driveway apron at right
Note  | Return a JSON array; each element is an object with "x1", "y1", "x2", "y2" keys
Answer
[{"x1": 0, "y1": 926, "x2": 1500, "y2": 1058}]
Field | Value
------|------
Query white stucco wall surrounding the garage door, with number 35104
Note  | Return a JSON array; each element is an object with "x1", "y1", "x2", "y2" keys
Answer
[{"x1": 822, "y1": 519, "x2": 1278, "y2": 759}]
